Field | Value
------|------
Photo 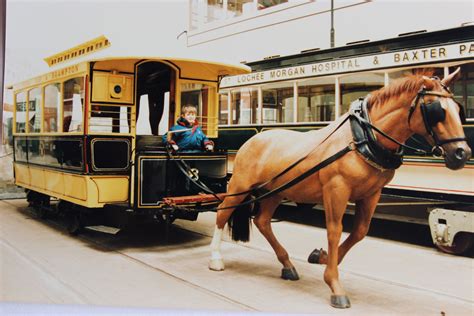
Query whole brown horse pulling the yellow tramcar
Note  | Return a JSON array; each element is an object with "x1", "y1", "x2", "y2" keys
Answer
[{"x1": 209, "y1": 69, "x2": 471, "y2": 308}]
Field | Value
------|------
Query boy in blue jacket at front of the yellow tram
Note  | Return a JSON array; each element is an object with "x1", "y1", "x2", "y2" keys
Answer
[{"x1": 163, "y1": 105, "x2": 214, "y2": 152}]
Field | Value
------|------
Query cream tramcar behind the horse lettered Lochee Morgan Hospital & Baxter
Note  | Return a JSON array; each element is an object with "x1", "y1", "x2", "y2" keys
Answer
[{"x1": 217, "y1": 25, "x2": 474, "y2": 252}]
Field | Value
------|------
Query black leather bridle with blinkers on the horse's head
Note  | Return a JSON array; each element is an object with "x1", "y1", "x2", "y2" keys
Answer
[{"x1": 408, "y1": 77, "x2": 467, "y2": 157}]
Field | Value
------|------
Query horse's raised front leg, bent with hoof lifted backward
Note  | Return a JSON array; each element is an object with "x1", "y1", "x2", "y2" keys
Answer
[{"x1": 312, "y1": 190, "x2": 382, "y2": 264}]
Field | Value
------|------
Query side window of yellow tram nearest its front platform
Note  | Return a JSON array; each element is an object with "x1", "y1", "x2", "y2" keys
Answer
[{"x1": 63, "y1": 77, "x2": 85, "y2": 132}]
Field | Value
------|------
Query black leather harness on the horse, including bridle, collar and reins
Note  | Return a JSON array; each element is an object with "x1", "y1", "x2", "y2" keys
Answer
[{"x1": 167, "y1": 78, "x2": 467, "y2": 212}]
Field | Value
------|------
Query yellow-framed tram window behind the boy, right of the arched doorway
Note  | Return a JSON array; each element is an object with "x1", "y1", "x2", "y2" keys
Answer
[{"x1": 181, "y1": 83, "x2": 217, "y2": 134}]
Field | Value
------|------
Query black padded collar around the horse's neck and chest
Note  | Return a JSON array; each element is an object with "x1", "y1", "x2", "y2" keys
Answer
[{"x1": 349, "y1": 95, "x2": 403, "y2": 170}]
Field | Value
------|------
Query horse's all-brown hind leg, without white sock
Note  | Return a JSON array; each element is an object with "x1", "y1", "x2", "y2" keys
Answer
[{"x1": 253, "y1": 196, "x2": 299, "y2": 281}]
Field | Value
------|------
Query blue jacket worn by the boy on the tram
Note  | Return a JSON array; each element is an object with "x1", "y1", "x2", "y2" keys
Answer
[{"x1": 163, "y1": 118, "x2": 214, "y2": 151}]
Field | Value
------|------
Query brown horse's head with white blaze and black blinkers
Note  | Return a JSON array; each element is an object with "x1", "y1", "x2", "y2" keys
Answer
[{"x1": 408, "y1": 68, "x2": 471, "y2": 170}]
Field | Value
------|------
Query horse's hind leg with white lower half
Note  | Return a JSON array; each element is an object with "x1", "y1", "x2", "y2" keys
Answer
[{"x1": 209, "y1": 195, "x2": 245, "y2": 271}]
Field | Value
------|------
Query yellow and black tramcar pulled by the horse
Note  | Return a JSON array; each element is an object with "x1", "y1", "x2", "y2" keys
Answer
[{"x1": 12, "y1": 36, "x2": 249, "y2": 233}]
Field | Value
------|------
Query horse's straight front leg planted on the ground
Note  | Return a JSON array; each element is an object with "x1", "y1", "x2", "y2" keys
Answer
[{"x1": 323, "y1": 185, "x2": 351, "y2": 308}]
